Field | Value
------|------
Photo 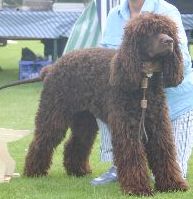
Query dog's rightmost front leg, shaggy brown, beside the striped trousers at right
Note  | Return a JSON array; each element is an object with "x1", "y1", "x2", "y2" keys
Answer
[{"x1": 146, "y1": 105, "x2": 188, "y2": 191}]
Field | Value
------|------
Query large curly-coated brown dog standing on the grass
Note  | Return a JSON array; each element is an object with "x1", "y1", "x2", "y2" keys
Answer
[{"x1": 24, "y1": 13, "x2": 188, "y2": 195}]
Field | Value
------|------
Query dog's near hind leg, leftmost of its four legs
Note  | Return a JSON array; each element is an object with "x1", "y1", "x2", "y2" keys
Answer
[{"x1": 24, "y1": 95, "x2": 68, "y2": 176}]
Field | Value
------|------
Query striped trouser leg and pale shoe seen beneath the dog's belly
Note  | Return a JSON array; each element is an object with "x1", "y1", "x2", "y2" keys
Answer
[{"x1": 91, "y1": 119, "x2": 117, "y2": 185}]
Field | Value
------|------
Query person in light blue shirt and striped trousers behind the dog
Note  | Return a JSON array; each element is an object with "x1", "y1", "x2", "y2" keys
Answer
[{"x1": 91, "y1": 0, "x2": 193, "y2": 185}]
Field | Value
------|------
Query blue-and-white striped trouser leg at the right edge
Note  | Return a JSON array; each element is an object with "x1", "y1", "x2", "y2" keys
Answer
[{"x1": 172, "y1": 110, "x2": 193, "y2": 178}]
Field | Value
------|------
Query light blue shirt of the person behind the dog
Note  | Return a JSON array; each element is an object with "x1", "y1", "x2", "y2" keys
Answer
[{"x1": 101, "y1": 0, "x2": 193, "y2": 120}]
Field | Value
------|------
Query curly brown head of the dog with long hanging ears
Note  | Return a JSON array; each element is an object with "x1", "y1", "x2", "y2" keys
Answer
[{"x1": 110, "y1": 13, "x2": 183, "y2": 88}]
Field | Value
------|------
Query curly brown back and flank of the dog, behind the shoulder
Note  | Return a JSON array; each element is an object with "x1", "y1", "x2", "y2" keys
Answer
[{"x1": 45, "y1": 48, "x2": 116, "y2": 120}]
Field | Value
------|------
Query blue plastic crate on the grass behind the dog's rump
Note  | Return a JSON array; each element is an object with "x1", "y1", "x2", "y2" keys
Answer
[{"x1": 19, "y1": 60, "x2": 52, "y2": 80}]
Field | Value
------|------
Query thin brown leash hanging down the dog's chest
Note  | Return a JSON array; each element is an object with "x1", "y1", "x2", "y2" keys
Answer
[{"x1": 139, "y1": 73, "x2": 153, "y2": 142}]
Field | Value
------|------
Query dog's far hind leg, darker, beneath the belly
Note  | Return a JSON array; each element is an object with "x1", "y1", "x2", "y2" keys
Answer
[{"x1": 64, "y1": 111, "x2": 97, "y2": 176}]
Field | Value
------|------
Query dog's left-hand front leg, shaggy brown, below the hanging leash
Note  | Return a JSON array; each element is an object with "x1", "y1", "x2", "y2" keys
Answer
[{"x1": 109, "y1": 112, "x2": 153, "y2": 195}]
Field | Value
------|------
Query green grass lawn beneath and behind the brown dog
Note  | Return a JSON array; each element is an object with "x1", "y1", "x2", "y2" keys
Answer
[{"x1": 0, "y1": 41, "x2": 193, "y2": 199}]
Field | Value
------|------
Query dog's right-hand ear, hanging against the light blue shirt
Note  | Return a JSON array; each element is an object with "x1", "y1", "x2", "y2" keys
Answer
[{"x1": 163, "y1": 38, "x2": 184, "y2": 87}]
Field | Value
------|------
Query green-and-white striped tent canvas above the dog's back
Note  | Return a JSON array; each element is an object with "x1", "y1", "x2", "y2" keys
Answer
[{"x1": 64, "y1": 0, "x2": 121, "y2": 53}]
